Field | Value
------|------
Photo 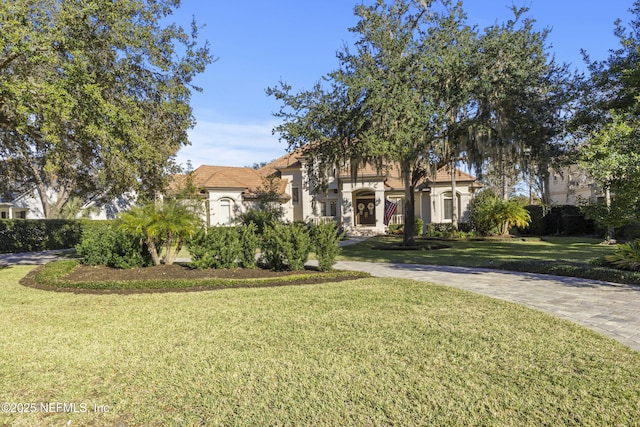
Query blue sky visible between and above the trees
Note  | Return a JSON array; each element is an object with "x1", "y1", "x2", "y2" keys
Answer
[{"x1": 173, "y1": 0, "x2": 633, "y2": 167}]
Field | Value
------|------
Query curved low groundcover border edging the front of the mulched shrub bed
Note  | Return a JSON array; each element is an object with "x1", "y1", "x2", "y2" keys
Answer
[{"x1": 20, "y1": 261, "x2": 370, "y2": 295}]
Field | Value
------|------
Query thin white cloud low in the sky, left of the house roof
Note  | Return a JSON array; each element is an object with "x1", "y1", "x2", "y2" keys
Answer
[{"x1": 172, "y1": 121, "x2": 287, "y2": 168}]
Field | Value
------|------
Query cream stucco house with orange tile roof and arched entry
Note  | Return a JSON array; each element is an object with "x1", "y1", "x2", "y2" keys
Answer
[{"x1": 193, "y1": 151, "x2": 481, "y2": 235}]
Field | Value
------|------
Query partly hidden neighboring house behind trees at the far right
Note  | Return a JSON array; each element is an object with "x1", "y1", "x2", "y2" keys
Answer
[{"x1": 547, "y1": 165, "x2": 604, "y2": 206}]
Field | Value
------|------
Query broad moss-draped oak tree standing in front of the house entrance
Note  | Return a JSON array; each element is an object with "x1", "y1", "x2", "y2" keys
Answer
[{"x1": 268, "y1": 0, "x2": 568, "y2": 245}]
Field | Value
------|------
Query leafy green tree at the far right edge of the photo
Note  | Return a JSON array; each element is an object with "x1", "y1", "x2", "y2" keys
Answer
[{"x1": 574, "y1": 1, "x2": 640, "y2": 232}]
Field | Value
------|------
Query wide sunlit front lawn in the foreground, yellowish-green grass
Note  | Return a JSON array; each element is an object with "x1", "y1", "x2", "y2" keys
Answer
[{"x1": 0, "y1": 267, "x2": 640, "y2": 426}]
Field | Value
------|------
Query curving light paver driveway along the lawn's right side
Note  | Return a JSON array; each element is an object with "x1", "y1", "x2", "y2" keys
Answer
[{"x1": 334, "y1": 261, "x2": 640, "y2": 351}]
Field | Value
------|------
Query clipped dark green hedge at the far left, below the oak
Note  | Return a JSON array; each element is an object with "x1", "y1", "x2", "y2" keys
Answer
[{"x1": 0, "y1": 219, "x2": 88, "y2": 253}]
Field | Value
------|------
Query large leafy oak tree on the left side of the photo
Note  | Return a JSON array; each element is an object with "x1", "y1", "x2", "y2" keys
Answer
[{"x1": 0, "y1": 0, "x2": 213, "y2": 218}]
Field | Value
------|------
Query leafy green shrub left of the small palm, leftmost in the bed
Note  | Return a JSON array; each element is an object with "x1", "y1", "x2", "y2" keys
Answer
[{"x1": 76, "y1": 221, "x2": 153, "y2": 268}]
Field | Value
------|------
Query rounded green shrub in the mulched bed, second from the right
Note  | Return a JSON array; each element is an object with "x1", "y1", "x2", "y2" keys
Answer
[{"x1": 261, "y1": 223, "x2": 311, "y2": 271}]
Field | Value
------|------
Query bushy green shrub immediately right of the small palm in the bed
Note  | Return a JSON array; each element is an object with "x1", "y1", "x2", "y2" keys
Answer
[{"x1": 187, "y1": 227, "x2": 242, "y2": 268}]
